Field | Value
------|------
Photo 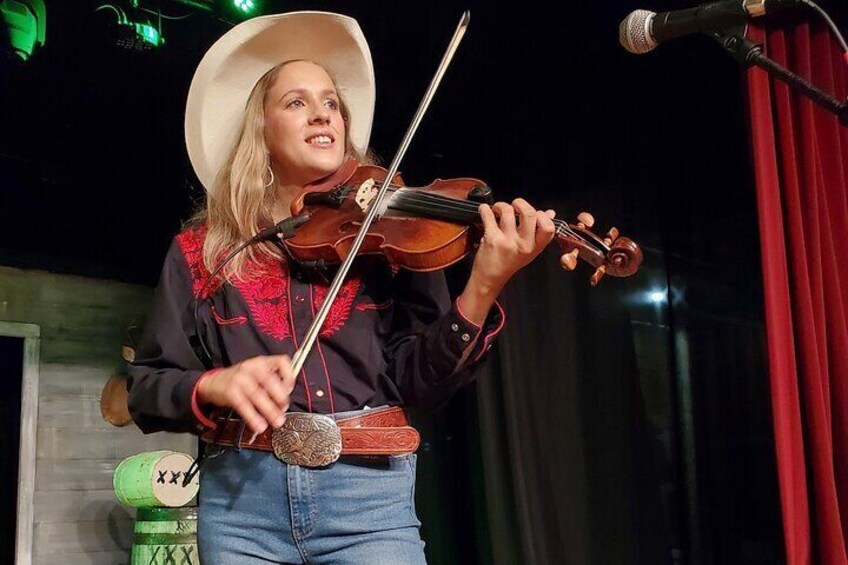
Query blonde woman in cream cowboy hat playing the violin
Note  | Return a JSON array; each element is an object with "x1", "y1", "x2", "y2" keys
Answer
[{"x1": 129, "y1": 12, "x2": 554, "y2": 565}]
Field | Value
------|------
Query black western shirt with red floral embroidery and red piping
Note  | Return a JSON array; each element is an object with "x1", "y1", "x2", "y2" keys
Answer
[{"x1": 127, "y1": 227, "x2": 504, "y2": 433}]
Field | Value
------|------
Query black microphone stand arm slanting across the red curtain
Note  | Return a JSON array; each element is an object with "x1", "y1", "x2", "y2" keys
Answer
[{"x1": 708, "y1": 28, "x2": 848, "y2": 126}]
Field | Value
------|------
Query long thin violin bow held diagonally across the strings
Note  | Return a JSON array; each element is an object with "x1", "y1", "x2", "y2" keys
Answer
[{"x1": 292, "y1": 10, "x2": 471, "y2": 375}]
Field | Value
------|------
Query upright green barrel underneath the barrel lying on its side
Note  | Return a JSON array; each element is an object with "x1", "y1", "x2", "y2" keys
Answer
[{"x1": 130, "y1": 506, "x2": 200, "y2": 565}]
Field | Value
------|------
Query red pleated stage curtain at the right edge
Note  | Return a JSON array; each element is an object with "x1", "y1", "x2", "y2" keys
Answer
[{"x1": 747, "y1": 16, "x2": 848, "y2": 565}]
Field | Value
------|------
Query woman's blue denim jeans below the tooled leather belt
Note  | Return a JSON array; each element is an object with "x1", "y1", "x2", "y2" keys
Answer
[{"x1": 197, "y1": 408, "x2": 426, "y2": 565}]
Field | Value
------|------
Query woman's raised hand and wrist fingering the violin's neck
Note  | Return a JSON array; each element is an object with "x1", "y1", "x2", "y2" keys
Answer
[{"x1": 460, "y1": 198, "x2": 556, "y2": 323}]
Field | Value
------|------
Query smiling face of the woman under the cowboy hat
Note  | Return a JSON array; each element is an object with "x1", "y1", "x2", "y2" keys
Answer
[{"x1": 265, "y1": 61, "x2": 345, "y2": 186}]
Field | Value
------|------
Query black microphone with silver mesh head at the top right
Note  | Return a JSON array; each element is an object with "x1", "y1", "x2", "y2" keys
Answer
[{"x1": 618, "y1": 0, "x2": 803, "y2": 54}]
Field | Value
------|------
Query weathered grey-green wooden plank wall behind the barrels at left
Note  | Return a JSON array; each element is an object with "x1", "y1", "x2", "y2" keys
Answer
[{"x1": 0, "y1": 267, "x2": 196, "y2": 565}]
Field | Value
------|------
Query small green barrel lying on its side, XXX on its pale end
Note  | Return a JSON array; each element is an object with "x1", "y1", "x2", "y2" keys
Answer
[{"x1": 112, "y1": 451, "x2": 200, "y2": 508}]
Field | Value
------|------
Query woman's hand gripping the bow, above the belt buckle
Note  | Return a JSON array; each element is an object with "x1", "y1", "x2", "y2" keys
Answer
[{"x1": 197, "y1": 355, "x2": 295, "y2": 434}]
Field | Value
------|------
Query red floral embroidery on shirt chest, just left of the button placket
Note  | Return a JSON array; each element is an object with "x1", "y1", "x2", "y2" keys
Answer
[{"x1": 235, "y1": 260, "x2": 292, "y2": 341}]
